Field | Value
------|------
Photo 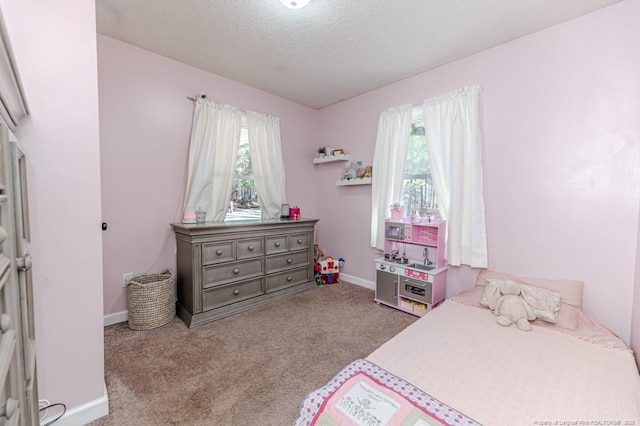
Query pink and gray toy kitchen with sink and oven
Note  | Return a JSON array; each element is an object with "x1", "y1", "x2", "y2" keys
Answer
[{"x1": 375, "y1": 206, "x2": 447, "y2": 316}]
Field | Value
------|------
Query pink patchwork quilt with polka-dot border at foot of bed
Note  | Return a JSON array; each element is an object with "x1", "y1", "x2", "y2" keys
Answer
[{"x1": 294, "y1": 359, "x2": 479, "y2": 426}]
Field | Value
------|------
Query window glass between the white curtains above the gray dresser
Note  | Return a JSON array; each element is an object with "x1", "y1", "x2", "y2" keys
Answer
[{"x1": 225, "y1": 117, "x2": 262, "y2": 220}]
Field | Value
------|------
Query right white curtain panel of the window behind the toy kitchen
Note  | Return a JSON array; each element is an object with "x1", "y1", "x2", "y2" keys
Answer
[{"x1": 424, "y1": 86, "x2": 488, "y2": 268}]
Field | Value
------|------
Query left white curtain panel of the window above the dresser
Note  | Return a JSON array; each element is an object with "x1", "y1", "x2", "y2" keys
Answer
[{"x1": 182, "y1": 97, "x2": 242, "y2": 223}]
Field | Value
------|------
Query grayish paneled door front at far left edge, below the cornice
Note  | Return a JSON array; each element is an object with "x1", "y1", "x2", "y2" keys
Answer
[{"x1": 0, "y1": 124, "x2": 39, "y2": 425}]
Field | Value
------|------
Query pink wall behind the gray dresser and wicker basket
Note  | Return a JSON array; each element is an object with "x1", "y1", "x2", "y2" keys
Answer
[{"x1": 98, "y1": 36, "x2": 318, "y2": 314}]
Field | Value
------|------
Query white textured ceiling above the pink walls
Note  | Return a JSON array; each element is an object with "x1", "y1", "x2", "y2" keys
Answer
[{"x1": 96, "y1": 0, "x2": 619, "y2": 108}]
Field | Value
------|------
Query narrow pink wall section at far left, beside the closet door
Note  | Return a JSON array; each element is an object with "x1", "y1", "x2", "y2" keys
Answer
[{"x1": 0, "y1": 0, "x2": 106, "y2": 410}]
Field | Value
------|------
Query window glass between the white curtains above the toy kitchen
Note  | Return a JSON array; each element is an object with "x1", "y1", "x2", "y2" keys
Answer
[{"x1": 401, "y1": 108, "x2": 438, "y2": 217}]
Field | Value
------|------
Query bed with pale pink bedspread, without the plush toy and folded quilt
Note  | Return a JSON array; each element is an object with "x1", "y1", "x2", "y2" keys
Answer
[{"x1": 298, "y1": 272, "x2": 640, "y2": 426}]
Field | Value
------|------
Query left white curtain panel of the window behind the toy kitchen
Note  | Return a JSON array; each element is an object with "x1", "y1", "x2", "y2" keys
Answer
[{"x1": 371, "y1": 104, "x2": 413, "y2": 250}]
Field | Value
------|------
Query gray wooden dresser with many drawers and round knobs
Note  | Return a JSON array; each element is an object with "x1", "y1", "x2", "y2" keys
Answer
[{"x1": 172, "y1": 219, "x2": 318, "y2": 328}]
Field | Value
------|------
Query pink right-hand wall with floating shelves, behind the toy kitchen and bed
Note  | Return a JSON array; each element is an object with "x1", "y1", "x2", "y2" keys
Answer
[{"x1": 315, "y1": 0, "x2": 640, "y2": 341}]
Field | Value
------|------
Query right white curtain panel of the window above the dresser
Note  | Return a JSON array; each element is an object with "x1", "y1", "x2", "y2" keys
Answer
[{"x1": 247, "y1": 111, "x2": 287, "y2": 219}]
